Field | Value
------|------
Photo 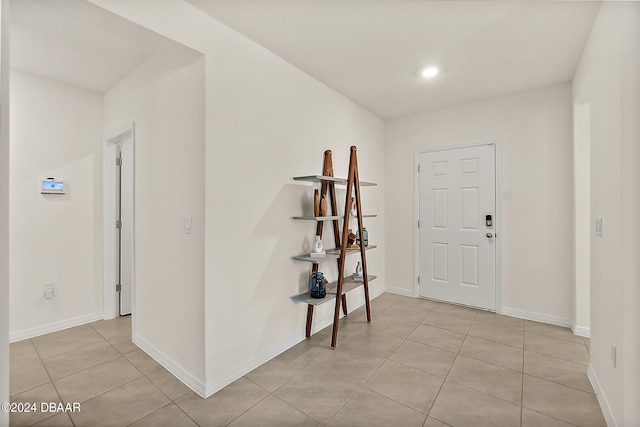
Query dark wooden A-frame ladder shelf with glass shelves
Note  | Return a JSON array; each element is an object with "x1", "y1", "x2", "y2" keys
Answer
[{"x1": 292, "y1": 146, "x2": 375, "y2": 348}]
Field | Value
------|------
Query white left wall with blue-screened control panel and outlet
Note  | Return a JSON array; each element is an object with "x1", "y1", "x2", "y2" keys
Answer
[{"x1": 9, "y1": 71, "x2": 103, "y2": 341}]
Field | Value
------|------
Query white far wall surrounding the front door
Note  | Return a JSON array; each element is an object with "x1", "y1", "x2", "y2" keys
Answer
[{"x1": 385, "y1": 84, "x2": 573, "y2": 325}]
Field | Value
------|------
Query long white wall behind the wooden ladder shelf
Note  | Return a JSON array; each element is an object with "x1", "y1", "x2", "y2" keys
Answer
[{"x1": 91, "y1": 0, "x2": 385, "y2": 400}]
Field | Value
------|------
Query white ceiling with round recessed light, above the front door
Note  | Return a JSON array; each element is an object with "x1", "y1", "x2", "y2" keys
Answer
[{"x1": 188, "y1": 0, "x2": 600, "y2": 119}]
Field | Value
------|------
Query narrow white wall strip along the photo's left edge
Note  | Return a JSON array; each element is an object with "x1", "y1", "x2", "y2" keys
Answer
[{"x1": 0, "y1": 0, "x2": 9, "y2": 426}]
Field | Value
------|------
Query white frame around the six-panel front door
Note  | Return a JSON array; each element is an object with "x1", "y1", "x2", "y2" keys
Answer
[{"x1": 413, "y1": 139, "x2": 504, "y2": 314}]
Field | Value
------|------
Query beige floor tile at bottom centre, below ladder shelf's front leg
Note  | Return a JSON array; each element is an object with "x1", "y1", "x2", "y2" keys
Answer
[{"x1": 274, "y1": 370, "x2": 358, "y2": 423}]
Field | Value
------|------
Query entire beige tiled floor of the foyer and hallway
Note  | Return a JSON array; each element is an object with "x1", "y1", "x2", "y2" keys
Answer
[{"x1": 11, "y1": 294, "x2": 605, "y2": 427}]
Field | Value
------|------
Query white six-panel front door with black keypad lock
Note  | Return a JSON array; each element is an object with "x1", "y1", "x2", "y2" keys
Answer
[{"x1": 419, "y1": 144, "x2": 496, "y2": 310}]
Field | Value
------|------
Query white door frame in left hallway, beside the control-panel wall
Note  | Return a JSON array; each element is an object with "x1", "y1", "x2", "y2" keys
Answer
[{"x1": 102, "y1": 122, "x2": 135, "y2": 320}]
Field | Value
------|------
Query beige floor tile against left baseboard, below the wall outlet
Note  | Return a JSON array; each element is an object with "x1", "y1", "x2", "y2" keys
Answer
[{"x1": 32, "y1": 325, "x2": 106, "y2": 360}]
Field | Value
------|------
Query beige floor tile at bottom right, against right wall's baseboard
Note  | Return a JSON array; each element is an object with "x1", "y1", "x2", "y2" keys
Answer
[{"x1": 522, "y1": 375, "x2": 606, "y2": 427}]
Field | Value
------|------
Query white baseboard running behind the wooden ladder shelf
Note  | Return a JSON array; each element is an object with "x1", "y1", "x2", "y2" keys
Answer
[{"x1": 205, "y1": 284, "x2": 385, "y2": 398}]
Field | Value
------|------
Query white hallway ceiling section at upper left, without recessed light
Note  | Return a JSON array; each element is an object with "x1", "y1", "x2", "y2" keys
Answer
[{"x1": 10, "y1": 0, "x2": 196, "y2": 92}]
